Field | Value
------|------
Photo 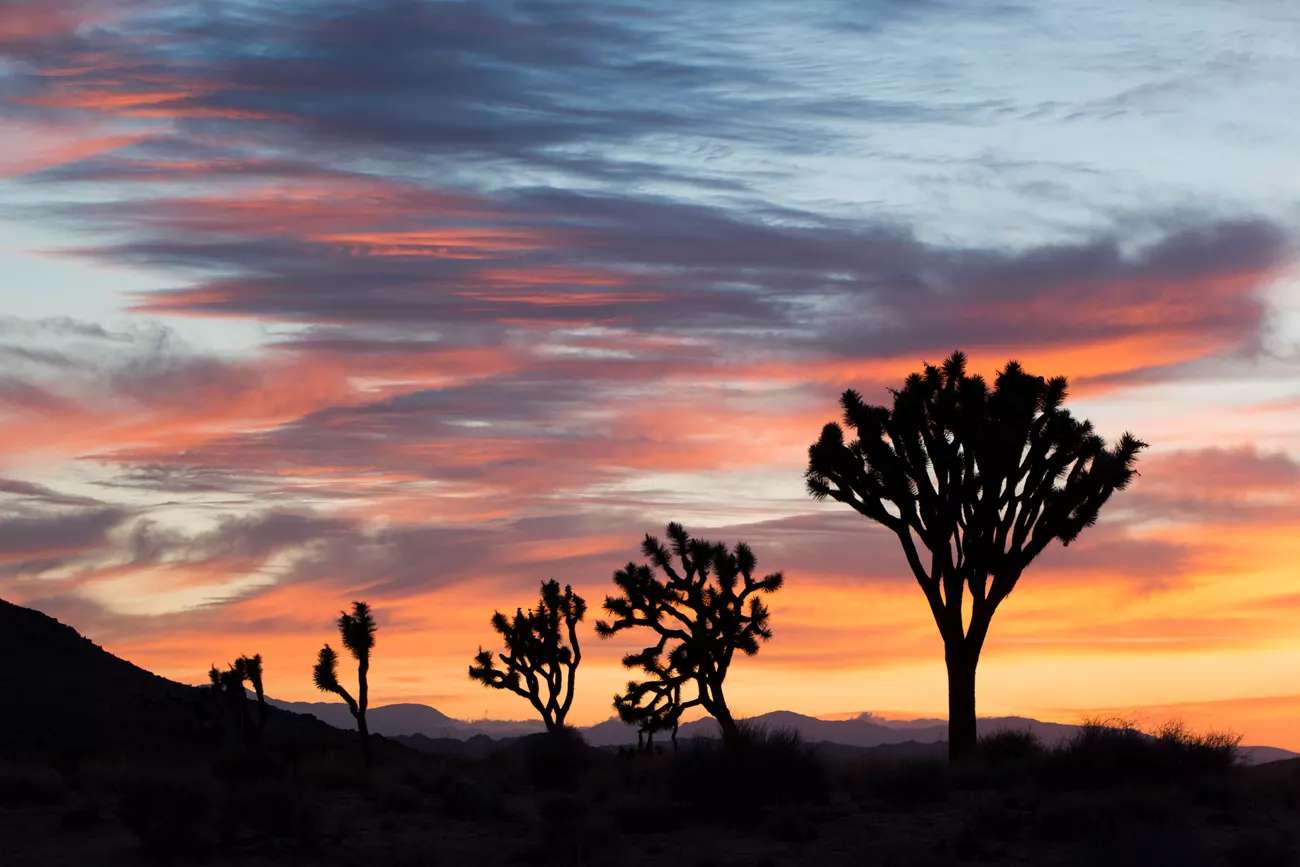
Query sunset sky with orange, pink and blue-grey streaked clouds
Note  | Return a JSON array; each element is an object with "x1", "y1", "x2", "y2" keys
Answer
[{"x1": 0, "y1": 0, "x2": 1300, "y2": 749}]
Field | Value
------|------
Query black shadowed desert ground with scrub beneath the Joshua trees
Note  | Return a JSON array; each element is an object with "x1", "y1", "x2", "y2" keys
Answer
[{"x1": 0, "y1": 729, "x2": 1300, "y2": 867}]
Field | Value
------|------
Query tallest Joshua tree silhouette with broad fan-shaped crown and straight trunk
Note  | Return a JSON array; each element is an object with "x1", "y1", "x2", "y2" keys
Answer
[{"x1": 806, "y1": 352, "x2": 1145, "y2": 759}]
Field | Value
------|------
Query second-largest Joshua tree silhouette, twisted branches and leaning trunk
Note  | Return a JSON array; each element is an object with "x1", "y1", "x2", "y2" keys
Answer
[{"x1": 595, "y1": 524, "x2": 784, "y2": 746}]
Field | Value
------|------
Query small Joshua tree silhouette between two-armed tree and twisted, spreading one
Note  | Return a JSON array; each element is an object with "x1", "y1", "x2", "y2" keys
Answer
[{"x1": 469, "y1": 580, "x2": 586, "y2": 732}]
